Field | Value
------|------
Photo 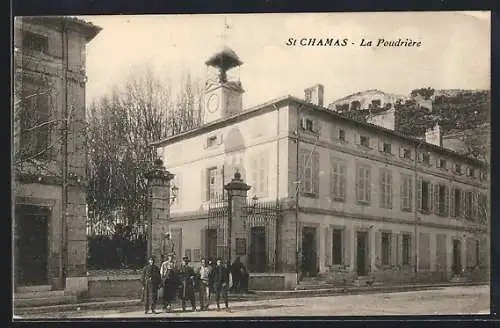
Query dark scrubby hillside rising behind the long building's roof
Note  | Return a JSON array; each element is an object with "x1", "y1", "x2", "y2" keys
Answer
[{"x1": 341, "y1": 88, "x2": 490, "y2": 159}]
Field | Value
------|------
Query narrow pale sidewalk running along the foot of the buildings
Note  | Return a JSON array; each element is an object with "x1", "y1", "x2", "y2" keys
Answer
[{"x1": 15, "y1": 282, "x2": 487, "y2": 315}]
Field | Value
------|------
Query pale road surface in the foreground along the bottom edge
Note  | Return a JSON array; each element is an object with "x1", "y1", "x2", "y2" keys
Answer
[{"x1": 15, "y1": 286, "x2": 490, "y2": 319}]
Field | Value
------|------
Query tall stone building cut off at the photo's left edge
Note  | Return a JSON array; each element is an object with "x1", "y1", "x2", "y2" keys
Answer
[{"x1": 12, "y1": 16, "x2": 101, "y2": 294}]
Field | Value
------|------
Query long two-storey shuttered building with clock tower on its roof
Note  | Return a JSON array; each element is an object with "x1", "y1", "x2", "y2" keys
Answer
[{"x1": 154, "y1": 50, "x2": 489, "y2": 286}]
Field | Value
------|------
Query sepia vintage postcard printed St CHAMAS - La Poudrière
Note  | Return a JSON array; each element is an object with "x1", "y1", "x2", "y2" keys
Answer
[{"x1": 11, "y1": 11, "x2": 491, "y2": 319}]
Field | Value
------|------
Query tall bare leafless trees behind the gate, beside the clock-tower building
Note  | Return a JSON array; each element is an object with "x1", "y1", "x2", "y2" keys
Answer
[{"x1": 87, "y1": 66, "x2": 202, "y2": 233}]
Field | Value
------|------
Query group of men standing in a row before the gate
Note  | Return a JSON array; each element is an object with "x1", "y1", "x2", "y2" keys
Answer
[{"x1": 142, "y1": 255, "x2": 236, "y2": 313}]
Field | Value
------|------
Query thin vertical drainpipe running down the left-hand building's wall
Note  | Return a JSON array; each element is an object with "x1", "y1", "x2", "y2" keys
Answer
[{"x1": 59, "y1": 21, "x2": 68, "y2": 288}]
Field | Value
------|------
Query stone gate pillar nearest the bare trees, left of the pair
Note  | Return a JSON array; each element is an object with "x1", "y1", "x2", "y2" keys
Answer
[{"x1": 146, "y1": 159, "x2": 178, "y2": 264}]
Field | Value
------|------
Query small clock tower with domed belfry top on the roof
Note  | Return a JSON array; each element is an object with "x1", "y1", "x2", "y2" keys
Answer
[{"x1": 204, "y1": 47, "x2": 245, "y2": 123}]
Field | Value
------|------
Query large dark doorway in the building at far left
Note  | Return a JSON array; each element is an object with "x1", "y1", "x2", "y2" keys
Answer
[{"x1": 14, "y1": 206, "x2": 48, "y2": 286}]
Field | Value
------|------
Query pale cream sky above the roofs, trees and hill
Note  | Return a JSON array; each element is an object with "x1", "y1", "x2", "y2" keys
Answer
[{"x1": 80, "y1": 12, "x2": 490, "y2": 108}]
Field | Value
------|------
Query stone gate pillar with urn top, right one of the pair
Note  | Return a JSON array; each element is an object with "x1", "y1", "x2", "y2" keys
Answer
[{"x1": 224, "y1": 172, "x2": 251, "y2": 263}]
